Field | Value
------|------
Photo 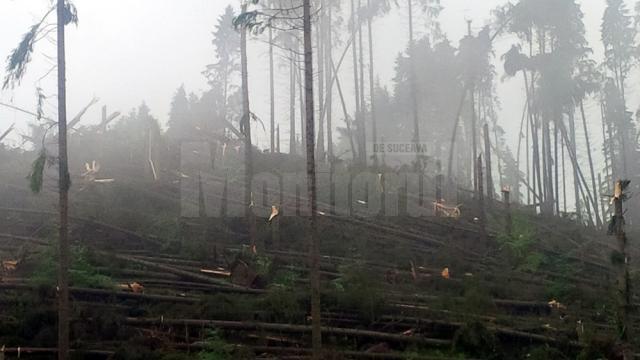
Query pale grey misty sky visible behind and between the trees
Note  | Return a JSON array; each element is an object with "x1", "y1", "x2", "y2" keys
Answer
[{"x1": 0, "y1": 0, "x2": 624, "y2": 166}]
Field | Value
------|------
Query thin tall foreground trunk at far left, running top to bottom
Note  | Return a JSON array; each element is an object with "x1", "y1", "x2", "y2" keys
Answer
[{"x1": 57, "y1": 0, "x2": 70, "y2": 360}]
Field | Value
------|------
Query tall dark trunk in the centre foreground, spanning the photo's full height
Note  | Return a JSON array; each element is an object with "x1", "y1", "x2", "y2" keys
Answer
[{"x1": 303, "y1": 0, "x2": 322, "y2": 359}]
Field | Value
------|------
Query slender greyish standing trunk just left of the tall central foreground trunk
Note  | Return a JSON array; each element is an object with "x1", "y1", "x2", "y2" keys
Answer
[{"x1": 240, "y1": 9, "x2": 257, "y2": 247}]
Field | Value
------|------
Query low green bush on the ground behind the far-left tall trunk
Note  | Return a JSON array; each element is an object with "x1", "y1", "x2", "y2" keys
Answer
[{"x1": 31, "y1": 247, "x2": 114, "y2": 289}]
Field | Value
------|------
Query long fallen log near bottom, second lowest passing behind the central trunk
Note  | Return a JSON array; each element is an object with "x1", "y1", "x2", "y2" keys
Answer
[{"x1": 125, "y1": 318, "x2": 451, "y2": 346}]
